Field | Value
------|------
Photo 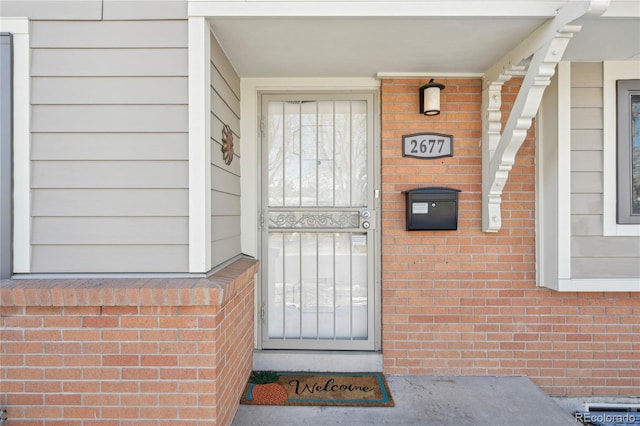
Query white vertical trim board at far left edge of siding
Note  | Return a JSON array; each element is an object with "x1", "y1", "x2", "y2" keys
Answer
[{"x1": 0, "y1": 18, "x2": 31, "y2": 274}]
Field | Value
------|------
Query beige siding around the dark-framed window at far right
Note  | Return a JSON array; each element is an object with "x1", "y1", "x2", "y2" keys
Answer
[{"x1": 571, "y1": 63, "x2": 640, "y2": 278}]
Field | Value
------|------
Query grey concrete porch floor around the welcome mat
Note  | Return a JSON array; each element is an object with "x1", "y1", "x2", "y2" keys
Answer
[{"x1": 233, "y1": 376, "x2": 580, "y2": 426}]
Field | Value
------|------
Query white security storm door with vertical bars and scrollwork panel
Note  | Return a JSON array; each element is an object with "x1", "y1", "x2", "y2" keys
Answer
[{"x1": 261, "y1": 93, "x2": 376, "y2": 350}]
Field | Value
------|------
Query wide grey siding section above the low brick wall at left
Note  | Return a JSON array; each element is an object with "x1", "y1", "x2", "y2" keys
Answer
[{"x1": 31, "y1": 20, "x2": 189, "y2": 273}]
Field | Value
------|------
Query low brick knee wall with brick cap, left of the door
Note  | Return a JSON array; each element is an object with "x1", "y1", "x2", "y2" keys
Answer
[{"x1": 0, "y1": 259, "x2": 257, "y2": 425}]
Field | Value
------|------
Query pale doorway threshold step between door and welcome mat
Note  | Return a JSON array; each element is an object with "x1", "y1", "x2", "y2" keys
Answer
[{"x1": 253, "y1": 350, "x2": 383, "y2": 373}]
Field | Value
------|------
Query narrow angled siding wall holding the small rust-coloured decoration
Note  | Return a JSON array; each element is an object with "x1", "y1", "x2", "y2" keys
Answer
[{"x1": 211, "y1": 31, "x2": 241, "y2": 267}]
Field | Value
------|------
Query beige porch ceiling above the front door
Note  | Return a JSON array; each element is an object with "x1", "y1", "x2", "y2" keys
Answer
[{"x1": 209, "y1": 0, "x2": 640, "y2": 77}]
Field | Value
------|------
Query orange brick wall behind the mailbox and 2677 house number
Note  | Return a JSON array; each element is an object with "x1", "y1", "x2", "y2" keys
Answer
[{"x1": 381, "y1": 79, "x2": 640, "y2": 396}]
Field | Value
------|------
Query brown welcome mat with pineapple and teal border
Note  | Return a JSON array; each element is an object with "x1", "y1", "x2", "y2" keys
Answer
[{"x1": 240, "y1": 371, "x2": 394, "y2": 407}]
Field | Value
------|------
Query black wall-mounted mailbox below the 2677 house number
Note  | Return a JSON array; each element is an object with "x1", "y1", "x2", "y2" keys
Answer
[{"x1": 403, "y1": 187, "x2": 460, "y2": 231}]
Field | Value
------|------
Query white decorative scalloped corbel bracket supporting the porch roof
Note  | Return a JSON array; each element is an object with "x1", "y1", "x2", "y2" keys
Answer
[{"x1": 482, "y1": 0, "x2": 609, "y2": 232}]
